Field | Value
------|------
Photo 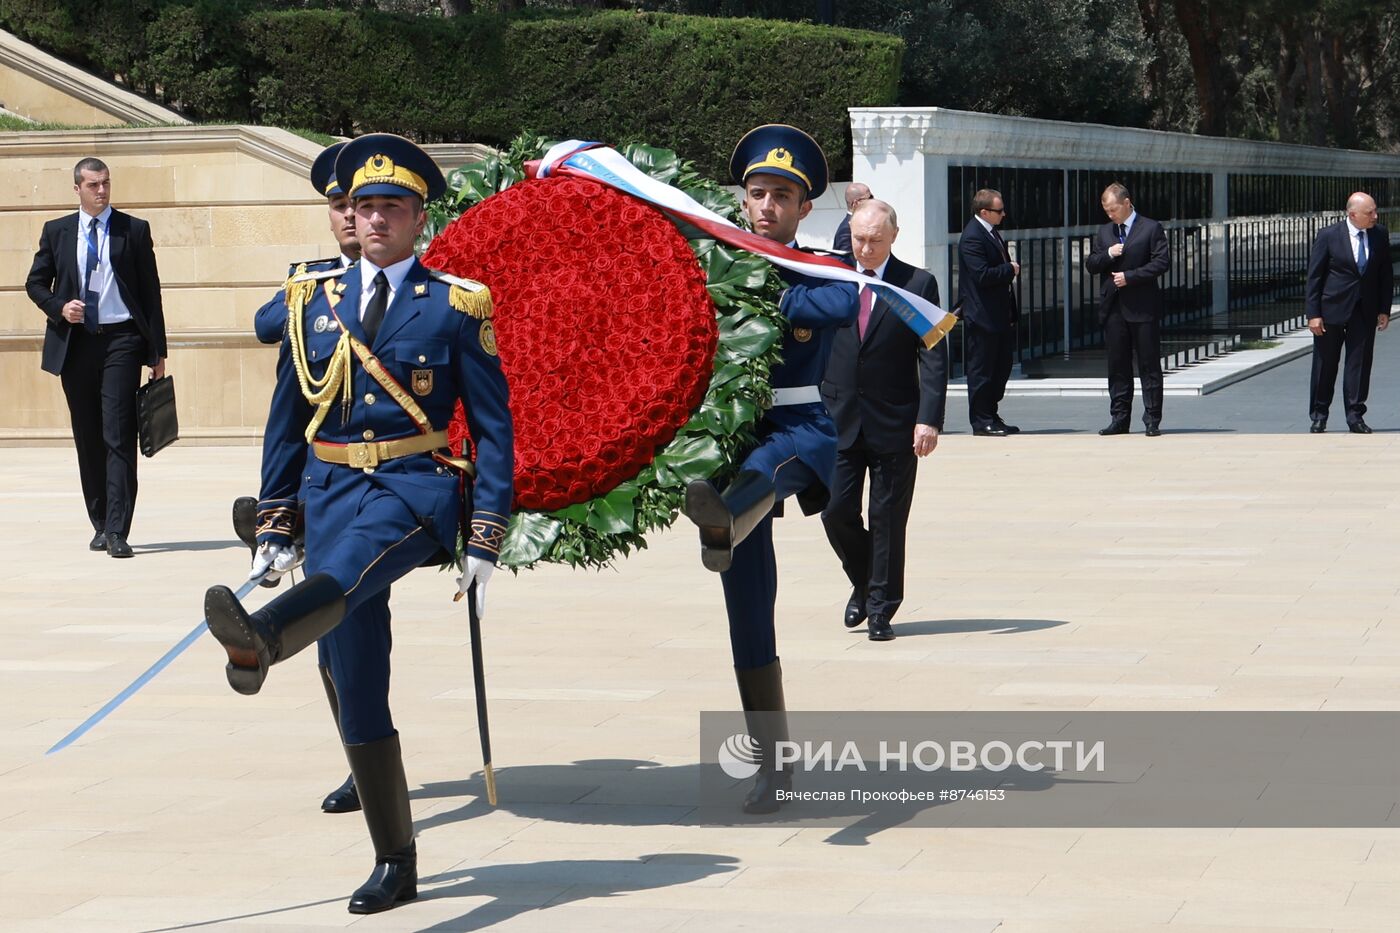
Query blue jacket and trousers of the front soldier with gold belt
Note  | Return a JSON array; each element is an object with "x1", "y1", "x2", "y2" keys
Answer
[{"x1": 258, "y1": 250, "x2": 512, "y2": 744}]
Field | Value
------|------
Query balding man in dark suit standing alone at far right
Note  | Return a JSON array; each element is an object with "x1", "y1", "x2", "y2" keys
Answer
[{"x1": 1306, "y1": 191, "x2": 1394, "y2": 434}]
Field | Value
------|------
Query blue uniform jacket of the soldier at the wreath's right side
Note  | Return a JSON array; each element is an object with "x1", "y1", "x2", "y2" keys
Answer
[{"x1": 759, "y1": 269, "x2": 860, "y2": 514}]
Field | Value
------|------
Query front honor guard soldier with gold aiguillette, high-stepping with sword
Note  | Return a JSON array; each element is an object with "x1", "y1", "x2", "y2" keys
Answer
[{"x1": 204, "y1": 133, "x2": 512, "y2": 913}]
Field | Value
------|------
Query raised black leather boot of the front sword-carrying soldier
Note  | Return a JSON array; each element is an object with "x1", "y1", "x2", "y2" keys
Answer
[{"x1": 204, "y1": 573, "x2": 346, "y2": 693}]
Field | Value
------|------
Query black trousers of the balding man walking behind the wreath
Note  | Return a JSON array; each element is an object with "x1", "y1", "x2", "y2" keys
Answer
[{"x1": 822, "y1": 431, "x2": 918, "y2": 621}]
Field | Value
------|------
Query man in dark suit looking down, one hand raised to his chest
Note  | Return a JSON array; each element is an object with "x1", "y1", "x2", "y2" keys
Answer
[{"x1": 1084, "y1": 182, "x2": 1172, "y2": 437}]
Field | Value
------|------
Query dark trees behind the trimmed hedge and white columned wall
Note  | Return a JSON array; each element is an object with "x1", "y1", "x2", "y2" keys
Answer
[{"x1": 636, "y1": 0, "x2": 1400, "y2": 150}]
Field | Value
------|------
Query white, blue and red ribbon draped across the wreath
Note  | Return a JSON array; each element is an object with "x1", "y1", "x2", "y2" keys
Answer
[{"x1": 525, "y1": 139, "x2": 958, "y2": 347}]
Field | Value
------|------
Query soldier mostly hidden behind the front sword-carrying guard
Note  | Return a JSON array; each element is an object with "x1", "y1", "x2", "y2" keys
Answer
[{"x1": 234, "y1": 143, "x2": 369, "y2": 813}]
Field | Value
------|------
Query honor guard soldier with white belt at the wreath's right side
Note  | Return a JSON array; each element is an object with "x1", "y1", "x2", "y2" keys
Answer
[{"x1": 685, "y1": 123, "x2": 860, "y2": 813}]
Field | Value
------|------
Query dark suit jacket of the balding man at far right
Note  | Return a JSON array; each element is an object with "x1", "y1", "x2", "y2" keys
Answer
[{"x1": 1305, "y1": 219, "x2": 1394, "y2": 324}]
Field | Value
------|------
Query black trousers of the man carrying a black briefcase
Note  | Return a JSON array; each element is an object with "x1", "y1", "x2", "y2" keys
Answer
[{"x1": 59, "y1": 322, "x2": 146, "y2": 537}]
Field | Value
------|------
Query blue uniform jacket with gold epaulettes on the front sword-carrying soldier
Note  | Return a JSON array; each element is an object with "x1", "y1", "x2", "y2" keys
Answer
[{"x1": 258, "y1": 262, "x2": 514, "y2": 560}]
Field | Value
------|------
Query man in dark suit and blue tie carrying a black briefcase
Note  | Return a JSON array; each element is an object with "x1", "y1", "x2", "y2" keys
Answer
[{"x1": 24, "y1": 158, "x2": 165, "y2": 558}]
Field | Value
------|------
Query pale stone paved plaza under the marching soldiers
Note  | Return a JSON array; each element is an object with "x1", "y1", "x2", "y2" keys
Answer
[{"x1": 0, "y1": 341, "x2": 1400, "y2": 933}]
